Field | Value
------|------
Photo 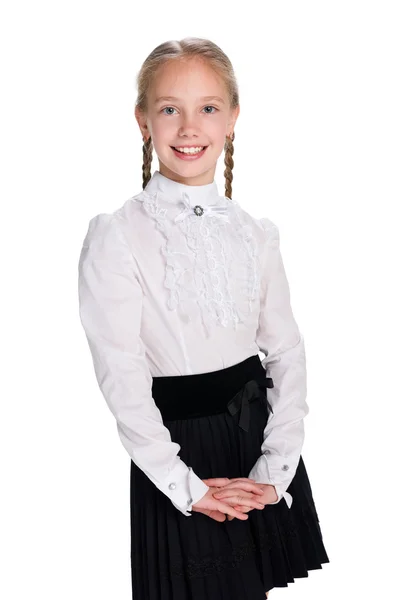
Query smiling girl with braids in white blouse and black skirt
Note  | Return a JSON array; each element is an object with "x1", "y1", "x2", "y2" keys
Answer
[{"x1": 79, "y1": 38, "x2": 329, "y2": 600}]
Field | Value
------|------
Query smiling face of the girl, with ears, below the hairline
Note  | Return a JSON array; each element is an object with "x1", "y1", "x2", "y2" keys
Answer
[{"x1": 135, "y1": 59, "x2": 239, "y2": 185}]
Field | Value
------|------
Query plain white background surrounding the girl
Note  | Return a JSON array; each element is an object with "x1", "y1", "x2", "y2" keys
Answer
[{"x1": 0, "y1": 0, "x2": 400, "y2": 600}]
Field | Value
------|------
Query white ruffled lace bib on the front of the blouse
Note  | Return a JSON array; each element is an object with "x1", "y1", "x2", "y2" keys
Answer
[{"x1": 134, "y1": 191, "x2": 260, "y2": 334}]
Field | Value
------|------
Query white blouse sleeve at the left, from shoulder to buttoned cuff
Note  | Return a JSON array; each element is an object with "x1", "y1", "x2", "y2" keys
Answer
[{"x1": 78, "y1": 213, "x2": 209, "y2": 516}]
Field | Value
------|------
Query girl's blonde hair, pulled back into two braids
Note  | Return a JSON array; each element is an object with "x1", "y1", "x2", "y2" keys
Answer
[{"x1": 136, "y1": 37, "x2": 239, "y2": 199}]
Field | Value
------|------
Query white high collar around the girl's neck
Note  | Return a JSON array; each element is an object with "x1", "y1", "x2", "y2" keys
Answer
[{"x1": 144, "y1": 171, "x2": 220, "y2": 207}]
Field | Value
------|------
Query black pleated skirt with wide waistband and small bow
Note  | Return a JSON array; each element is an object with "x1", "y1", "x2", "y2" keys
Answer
[{"x1": 130, "y1": 355, "x2": 330, "y2": 600}]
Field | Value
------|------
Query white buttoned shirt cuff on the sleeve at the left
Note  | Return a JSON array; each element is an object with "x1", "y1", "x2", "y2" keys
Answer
[{"x1": 158, "y1": 460, "x2": 210, "y2": 517}]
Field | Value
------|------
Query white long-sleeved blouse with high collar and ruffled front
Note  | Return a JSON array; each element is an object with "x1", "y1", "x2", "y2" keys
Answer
[{"x1": 78, "y1": 171, "x2": 309, "y2": 516}]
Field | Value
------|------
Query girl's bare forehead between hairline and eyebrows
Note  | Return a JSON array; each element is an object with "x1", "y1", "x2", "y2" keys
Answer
[{"x1": 150, "y1": 58, "x2": 227, "y2": 102}]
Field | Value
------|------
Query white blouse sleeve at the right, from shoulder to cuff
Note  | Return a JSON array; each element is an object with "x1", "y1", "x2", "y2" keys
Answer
[{"x1": 248, "y1": 218, "x2": 309, "y2": 508}]
